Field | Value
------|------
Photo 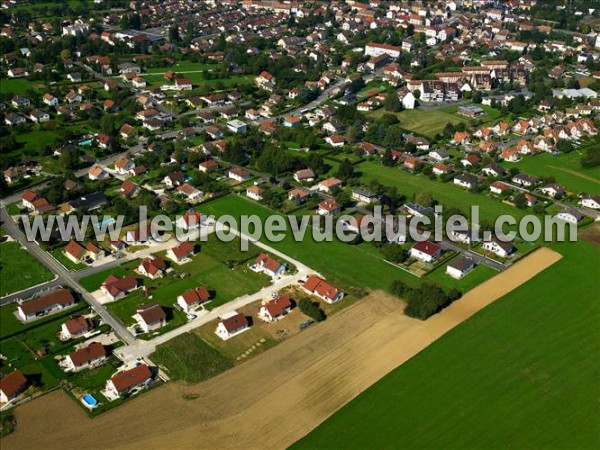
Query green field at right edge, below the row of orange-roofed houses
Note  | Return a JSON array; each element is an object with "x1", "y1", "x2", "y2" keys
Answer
[{"x1": 503, "y1": 150, "x2": 600, "y2": 194}]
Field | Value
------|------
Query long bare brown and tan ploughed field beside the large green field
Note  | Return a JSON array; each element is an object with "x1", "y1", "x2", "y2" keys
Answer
[{"x1": 2, "y1": 248, "x2": 560, "y2": 450}]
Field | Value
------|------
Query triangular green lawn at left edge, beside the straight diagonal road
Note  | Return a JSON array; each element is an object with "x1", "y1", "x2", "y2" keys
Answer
[{"x1": 0, "y1": 241, "x2": 54, "y2": 297}]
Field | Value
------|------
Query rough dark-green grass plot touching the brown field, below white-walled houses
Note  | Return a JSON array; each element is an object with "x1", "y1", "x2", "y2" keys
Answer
[{"x1": 150, "y1": 333, "x2": 233, "y2": 383}]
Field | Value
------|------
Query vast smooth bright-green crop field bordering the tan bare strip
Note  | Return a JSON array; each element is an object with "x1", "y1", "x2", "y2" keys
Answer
[{"x1": 293, "y1": 237, "x2": 600, "y2": 449}]
